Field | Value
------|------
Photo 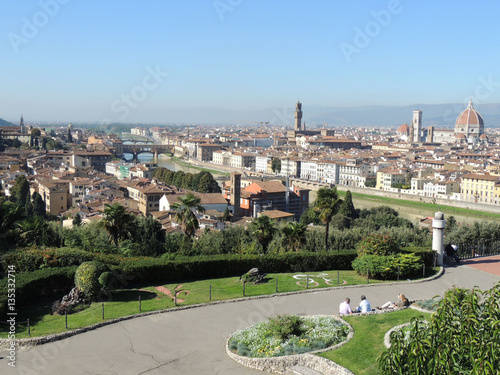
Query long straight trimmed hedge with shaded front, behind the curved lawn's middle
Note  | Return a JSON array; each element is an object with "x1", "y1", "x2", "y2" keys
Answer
[{"x1": 117, "y1": 251, "x2": 357, "y2": 283}]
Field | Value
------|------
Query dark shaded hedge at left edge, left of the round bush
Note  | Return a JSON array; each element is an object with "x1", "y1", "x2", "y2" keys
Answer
[{"x1": 0, "y1": 266, "x2": 77, "y2": 316}]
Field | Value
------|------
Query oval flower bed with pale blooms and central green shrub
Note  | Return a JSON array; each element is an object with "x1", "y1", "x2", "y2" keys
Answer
[{"x1": 229, "y1": 315, "x2": 349, "y2": 358}]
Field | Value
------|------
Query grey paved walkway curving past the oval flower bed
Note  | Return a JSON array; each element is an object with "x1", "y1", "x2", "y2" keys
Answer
[{"x1": 0, "y1": 257, "x2": 500, "y2": 375}]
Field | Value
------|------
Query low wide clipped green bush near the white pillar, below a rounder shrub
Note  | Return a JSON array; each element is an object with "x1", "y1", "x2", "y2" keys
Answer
[{"x1": 352, "y1": 254, "x2": 422, "y2": 280}]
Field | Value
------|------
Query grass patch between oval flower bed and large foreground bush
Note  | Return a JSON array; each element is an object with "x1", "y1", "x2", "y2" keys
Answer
[{"x1": 321, "y1": 309, "x2": 430, "y2": 375}]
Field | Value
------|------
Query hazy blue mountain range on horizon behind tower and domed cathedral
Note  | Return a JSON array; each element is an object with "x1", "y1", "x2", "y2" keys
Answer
[{"x1": 158, "y1": 103, "x2": 500, "y2": 128}]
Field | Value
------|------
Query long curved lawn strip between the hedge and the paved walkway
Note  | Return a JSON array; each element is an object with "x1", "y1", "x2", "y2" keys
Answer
[{"x1": 0, "y1": 269, "x2": 436, "y2": 338}]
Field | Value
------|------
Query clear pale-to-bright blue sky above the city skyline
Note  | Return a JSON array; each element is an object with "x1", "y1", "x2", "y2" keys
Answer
[{"x1": 0, "y1": 0, "x2": 500, "y2": 122}]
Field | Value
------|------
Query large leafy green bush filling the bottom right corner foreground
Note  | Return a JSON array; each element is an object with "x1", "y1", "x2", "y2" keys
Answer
[{"x1": 378, "y1": 283, "x2": 500, "y2": 375}]
